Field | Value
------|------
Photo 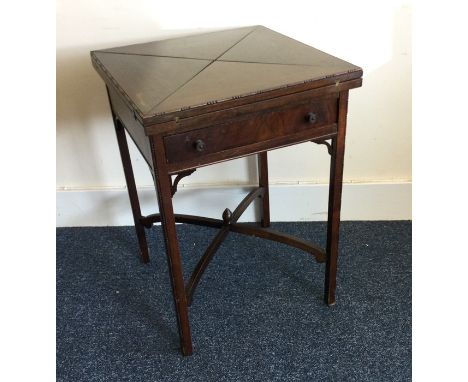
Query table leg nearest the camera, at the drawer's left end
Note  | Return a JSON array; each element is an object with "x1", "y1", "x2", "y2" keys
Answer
[{"x1": 151, "y1": 136, "x2": 192, "y2": 356}]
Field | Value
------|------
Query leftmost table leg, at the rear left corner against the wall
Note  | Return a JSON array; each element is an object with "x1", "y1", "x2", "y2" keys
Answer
[{"x1": 109, "y1": 93, "x2": 149, "y2": 263}]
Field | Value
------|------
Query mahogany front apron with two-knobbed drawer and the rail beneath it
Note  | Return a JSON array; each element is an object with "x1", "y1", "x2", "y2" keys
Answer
[{"x1": 163, "y1": 96, "x2": 338, "y2": 174}]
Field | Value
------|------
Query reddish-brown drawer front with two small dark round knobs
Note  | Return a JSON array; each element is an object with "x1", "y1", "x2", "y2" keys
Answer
[{"x1": 164, "y1": 97, "x2": 338, "y2": 164}]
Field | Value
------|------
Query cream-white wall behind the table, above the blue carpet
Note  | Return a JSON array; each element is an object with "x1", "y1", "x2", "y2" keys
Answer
[{"x1": 57, "y1": 0, "x2": 411, "y2": 225}]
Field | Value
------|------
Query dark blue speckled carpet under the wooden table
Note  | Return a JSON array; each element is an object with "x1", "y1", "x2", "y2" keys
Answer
[{"x1": 57, "y1": 222, "x2": 411, "y2": 382}]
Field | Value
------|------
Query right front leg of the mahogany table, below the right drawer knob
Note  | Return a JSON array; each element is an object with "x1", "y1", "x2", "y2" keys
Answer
[{"x1": 325, "y1": 91, "x2": 348, "y2": 305}]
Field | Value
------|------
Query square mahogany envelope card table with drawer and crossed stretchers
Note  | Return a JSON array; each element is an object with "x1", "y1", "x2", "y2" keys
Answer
[{"x1": 91, "y1": 26, "x2": 362, "y2": 355}]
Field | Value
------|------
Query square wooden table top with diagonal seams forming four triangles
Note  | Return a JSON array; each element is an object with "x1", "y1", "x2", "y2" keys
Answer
[{"x1": 91, "y1": 26, "x2": 362, "y2": 124}]
